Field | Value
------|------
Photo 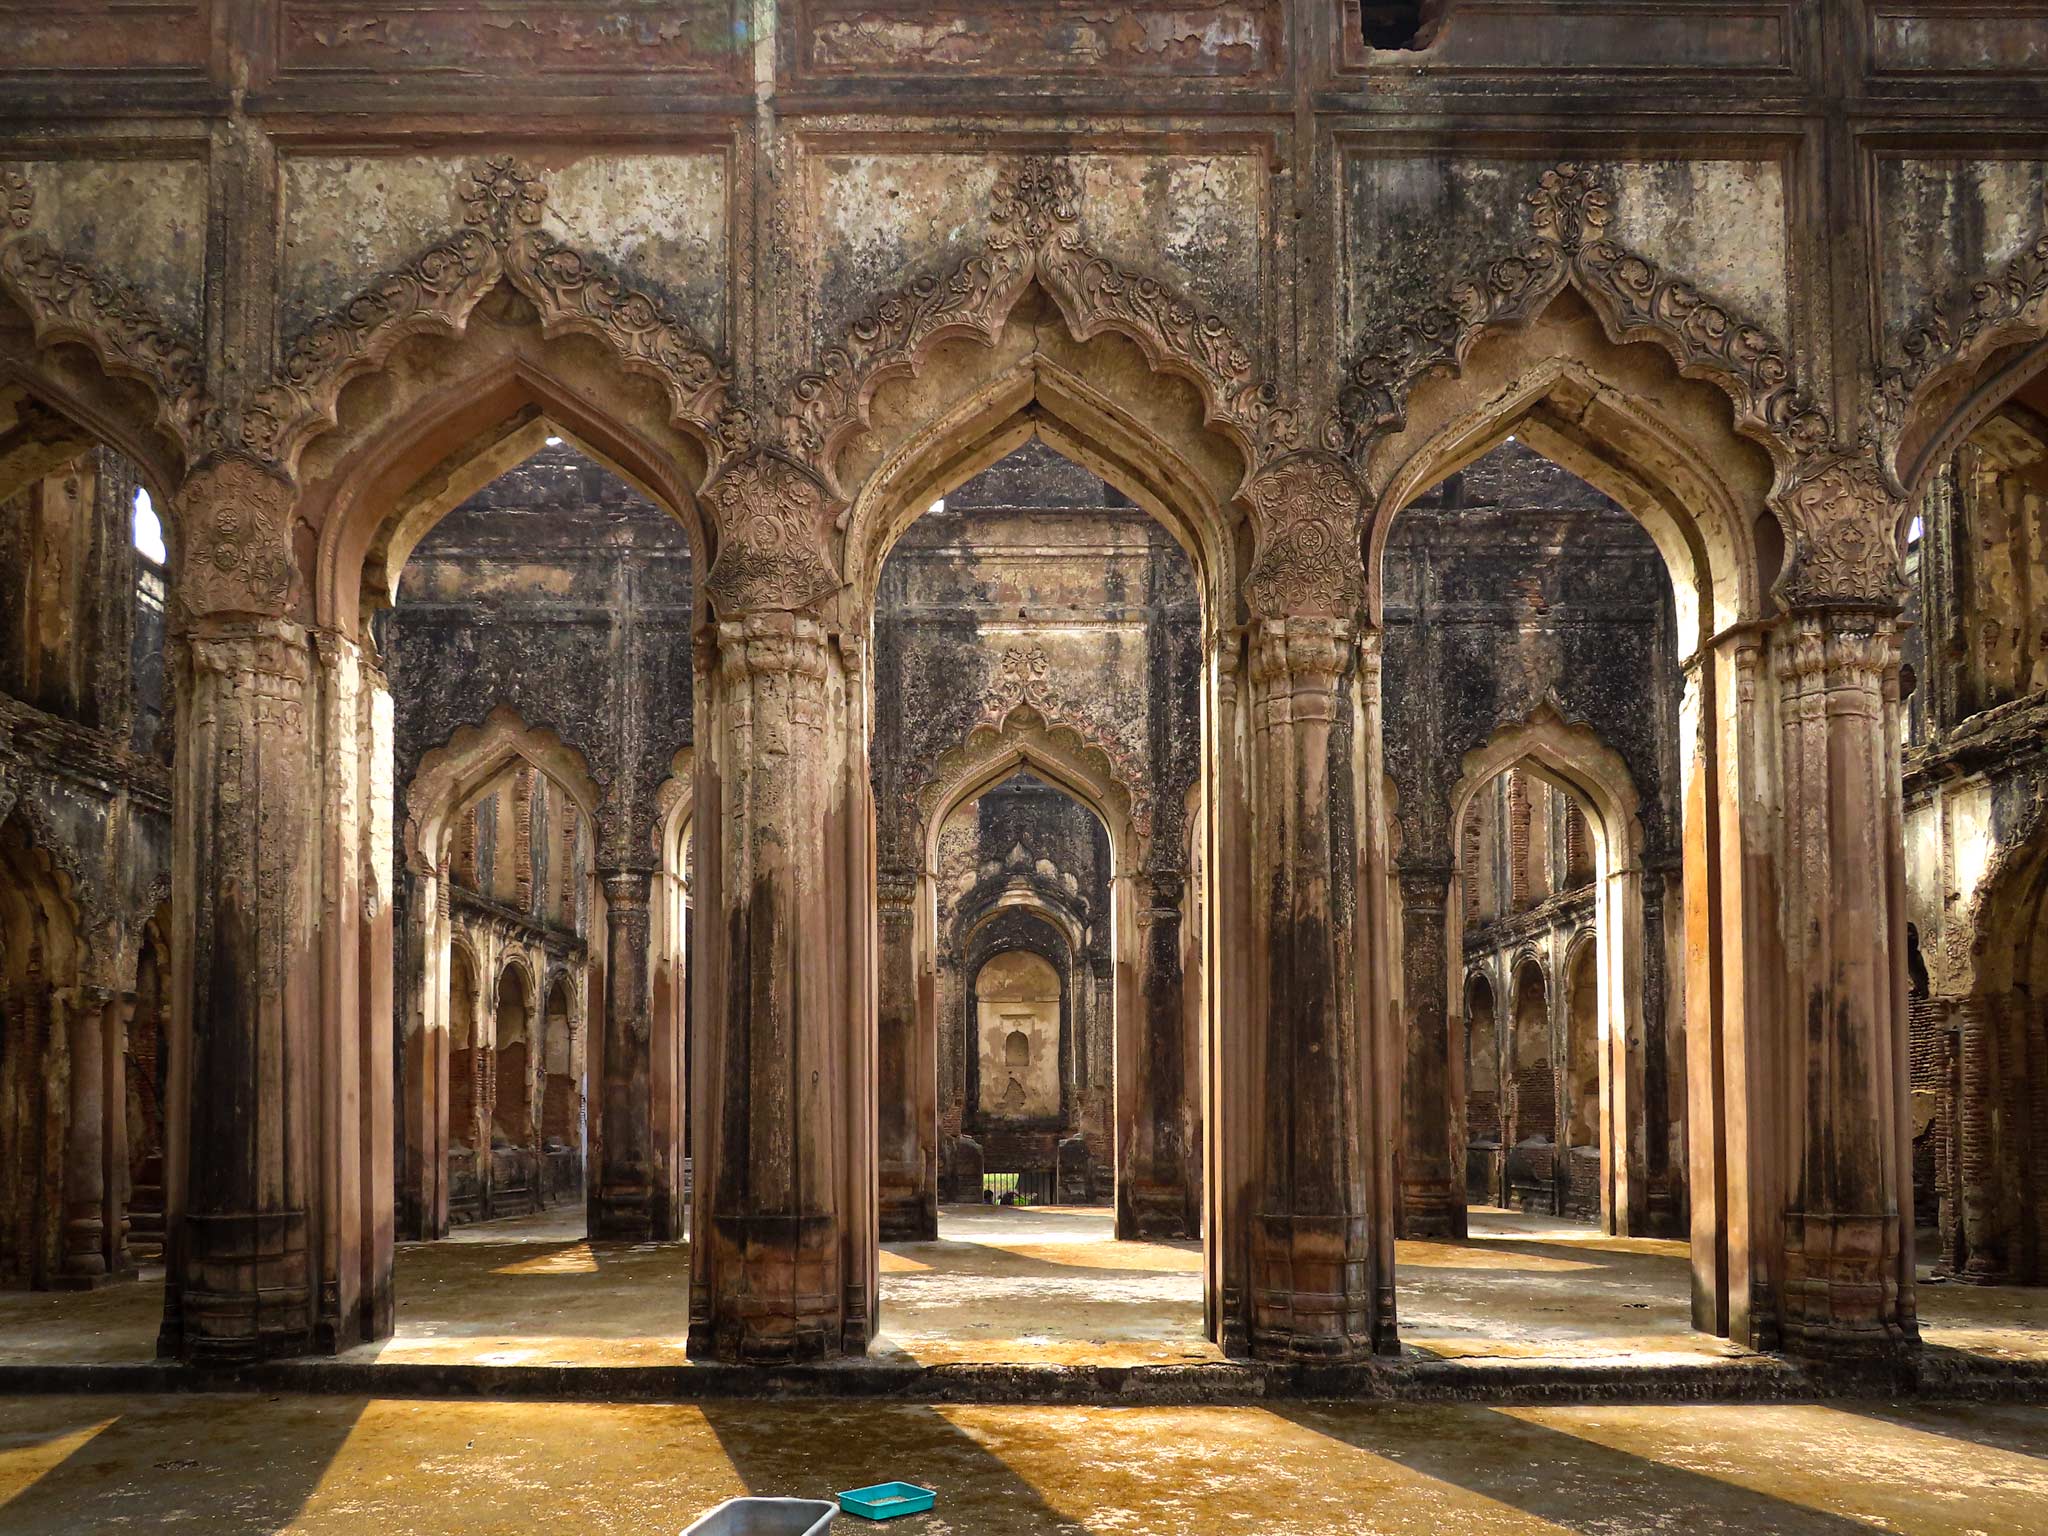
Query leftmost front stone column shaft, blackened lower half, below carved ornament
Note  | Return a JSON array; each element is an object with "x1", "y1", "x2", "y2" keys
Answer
[{"x1": 160, "y1": 618, "x2": 317, "y2": 1364}]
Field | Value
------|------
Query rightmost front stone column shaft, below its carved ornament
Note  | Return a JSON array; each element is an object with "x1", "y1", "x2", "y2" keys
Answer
[{"x1": 1774, "y1": 606, "x2": 1916, "y2": 1356}]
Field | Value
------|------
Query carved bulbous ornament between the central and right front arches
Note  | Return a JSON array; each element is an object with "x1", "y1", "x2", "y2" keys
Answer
[{"x1": 1245, "y1": 453, "x2": 1364, "y2": 618}]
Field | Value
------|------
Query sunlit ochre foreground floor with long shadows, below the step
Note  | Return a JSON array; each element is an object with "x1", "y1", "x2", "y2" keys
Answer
[{"x1": 0, "y1": 1395, "x2": 2048, "y2": 1536}]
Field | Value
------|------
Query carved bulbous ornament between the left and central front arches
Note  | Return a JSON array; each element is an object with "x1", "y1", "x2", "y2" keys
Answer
[{"x1": 705, "y1": 449, "x2": 840, "y2": 618}]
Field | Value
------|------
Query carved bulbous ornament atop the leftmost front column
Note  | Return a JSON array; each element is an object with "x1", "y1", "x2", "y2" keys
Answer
[{"x1": 176, "y1": 455, "x2": 299, "y2": 616}]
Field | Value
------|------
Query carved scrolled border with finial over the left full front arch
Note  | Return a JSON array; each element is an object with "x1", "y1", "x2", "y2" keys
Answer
[{"x1": 226, "y1": 158, "x2": 737, "y2": 481}]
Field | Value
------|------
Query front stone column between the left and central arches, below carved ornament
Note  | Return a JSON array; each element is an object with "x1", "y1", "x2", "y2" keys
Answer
[{"x1": 690, "y1": 612, "x2": 851, "y2": 1362}]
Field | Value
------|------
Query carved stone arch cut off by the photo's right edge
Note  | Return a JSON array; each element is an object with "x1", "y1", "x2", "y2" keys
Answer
[{"x1": 1880, "y1": 188, "x2": 2048, "y2": 504}]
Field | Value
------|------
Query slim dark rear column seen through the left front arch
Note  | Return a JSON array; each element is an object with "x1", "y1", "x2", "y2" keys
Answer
[{"x1": 590, "y1": 868, "x2": 653, "y2": 1243}]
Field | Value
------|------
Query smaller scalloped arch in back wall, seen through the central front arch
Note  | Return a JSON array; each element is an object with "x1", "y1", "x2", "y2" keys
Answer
[{"x1": 913, "y1": 702, "x2": 1151, "y2": 874}]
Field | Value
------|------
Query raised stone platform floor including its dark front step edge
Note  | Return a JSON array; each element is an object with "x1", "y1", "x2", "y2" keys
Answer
[{"x1": 0, "y1": 1206, "x2": 2048, "y2": 1405}]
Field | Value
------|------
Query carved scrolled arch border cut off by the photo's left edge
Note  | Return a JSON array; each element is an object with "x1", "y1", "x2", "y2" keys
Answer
[{"x1": 0, "y1": 168, "x2": 205, "y2": 453}]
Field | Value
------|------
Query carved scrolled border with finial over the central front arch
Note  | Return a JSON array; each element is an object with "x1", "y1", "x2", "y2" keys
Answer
[{"x1": 778, "y1": 156, "x2": 1300, "y2": 494}]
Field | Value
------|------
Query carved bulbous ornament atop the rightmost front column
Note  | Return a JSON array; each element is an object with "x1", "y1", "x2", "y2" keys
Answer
[{"x1": 1772, "y1": 455, "x2": 1907, "y2": 610}]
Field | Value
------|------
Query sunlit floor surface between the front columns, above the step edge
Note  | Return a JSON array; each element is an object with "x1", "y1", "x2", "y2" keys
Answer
[{"x1": 0, "y1": 1206, "x2": 2048, "y2": 1366}]
